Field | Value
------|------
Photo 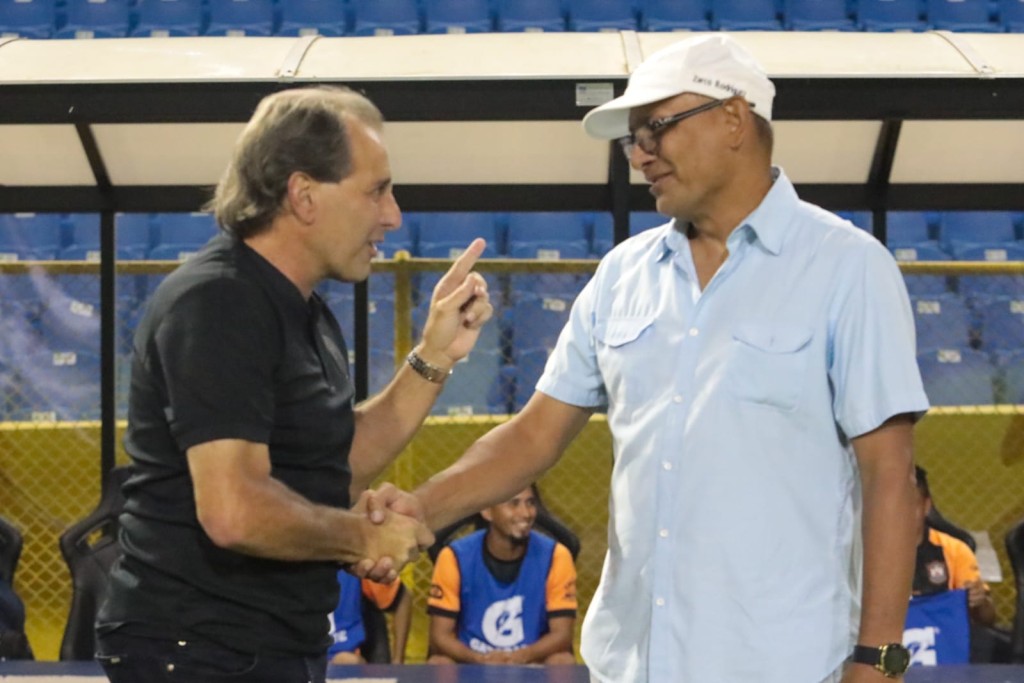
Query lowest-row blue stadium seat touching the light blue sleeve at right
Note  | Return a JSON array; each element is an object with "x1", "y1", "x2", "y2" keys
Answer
[{"x1": 918, "y1": 348, "x2": 996, "y2": 405}]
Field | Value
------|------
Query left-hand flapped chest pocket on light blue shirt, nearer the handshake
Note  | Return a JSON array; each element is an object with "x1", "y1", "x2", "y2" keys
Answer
[{"x1": 594, "y1": 315, "x2": 654, "y2": 405}]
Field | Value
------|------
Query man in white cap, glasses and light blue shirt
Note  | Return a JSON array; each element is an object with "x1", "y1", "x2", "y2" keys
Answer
[{"x1": 382, "y1": 35, "x2": 928, "y2": 683}]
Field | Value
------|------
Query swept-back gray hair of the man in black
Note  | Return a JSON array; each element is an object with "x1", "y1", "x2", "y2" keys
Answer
[{"x1": 207, "y1": 86, "x2": 384, "y2": 239}]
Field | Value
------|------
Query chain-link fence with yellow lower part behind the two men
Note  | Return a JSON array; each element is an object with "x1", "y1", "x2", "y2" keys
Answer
[{"x1": 0, "y1": 211, "x2": 1024, "y2": 661}]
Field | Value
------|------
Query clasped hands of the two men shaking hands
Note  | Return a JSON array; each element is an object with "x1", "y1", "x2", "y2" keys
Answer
[{"x1": 348, "y1": 483, "x2": 434, "y2": 584}]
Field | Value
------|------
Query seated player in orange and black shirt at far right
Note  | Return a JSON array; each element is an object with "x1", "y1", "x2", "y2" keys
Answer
[{"x1": 913, "y1": 467, "x2": 995, "y2": 626}]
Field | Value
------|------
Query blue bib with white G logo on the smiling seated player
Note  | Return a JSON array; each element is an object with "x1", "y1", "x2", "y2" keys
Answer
[{"x1": 452, "y1": 529, "x2": 555, "y2": 652}]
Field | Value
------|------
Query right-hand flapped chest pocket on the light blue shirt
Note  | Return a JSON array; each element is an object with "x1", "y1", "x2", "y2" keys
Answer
[{"x1": 729, "y1": 324, "x2": 814, "y2": 411}]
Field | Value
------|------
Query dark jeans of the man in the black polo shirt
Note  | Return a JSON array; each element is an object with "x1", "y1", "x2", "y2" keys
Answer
[{"x1": 96, "y1": 631, "x2": 327, "y2": 683}]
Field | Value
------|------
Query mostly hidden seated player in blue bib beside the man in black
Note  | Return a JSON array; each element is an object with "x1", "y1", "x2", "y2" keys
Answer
[{"x1": 327, "y1": 569, "x2": 413, "y2": 665}]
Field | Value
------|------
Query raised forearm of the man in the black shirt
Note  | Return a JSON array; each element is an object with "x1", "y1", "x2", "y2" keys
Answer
[{"x1": 349, "y1": 348, "x2": 446, "y2": 493}]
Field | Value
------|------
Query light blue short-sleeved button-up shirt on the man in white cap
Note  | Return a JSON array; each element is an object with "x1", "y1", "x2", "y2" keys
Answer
[{"x1": 538, "y1": 171, "x2": 928, "y2": 683}]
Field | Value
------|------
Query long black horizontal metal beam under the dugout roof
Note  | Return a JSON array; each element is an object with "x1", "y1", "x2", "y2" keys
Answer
[{"x1": 0, "y1": 77, "x2": 1024, "y2": 124}]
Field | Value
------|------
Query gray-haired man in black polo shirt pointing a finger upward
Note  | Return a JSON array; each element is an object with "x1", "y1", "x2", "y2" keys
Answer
[{"x1": 97, "y1": 88, "x2": 492, "y2": 683}]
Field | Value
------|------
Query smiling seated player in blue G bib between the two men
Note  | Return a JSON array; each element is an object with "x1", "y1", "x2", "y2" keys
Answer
[{"x1": 427, "y1": 486, "x2": 577, "y2": 665}]
